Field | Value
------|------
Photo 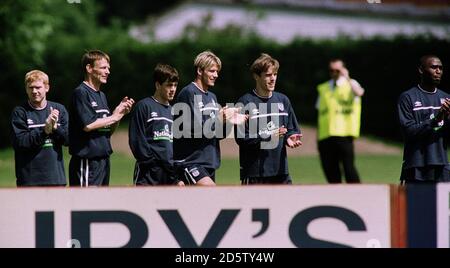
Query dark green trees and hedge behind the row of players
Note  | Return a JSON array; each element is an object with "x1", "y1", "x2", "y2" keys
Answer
[{"x1": 0, "y1": 0, "x2": 450, "y2": 147}]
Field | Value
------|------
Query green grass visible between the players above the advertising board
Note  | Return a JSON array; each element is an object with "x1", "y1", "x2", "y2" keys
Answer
[{"x1": 0, "y1": 149, "x2": 408, "y2": 187}]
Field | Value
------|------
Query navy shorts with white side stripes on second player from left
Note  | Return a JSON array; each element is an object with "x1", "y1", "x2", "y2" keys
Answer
[{"x1": 69, "y1": 156, "x2": 110, "y2": 187}]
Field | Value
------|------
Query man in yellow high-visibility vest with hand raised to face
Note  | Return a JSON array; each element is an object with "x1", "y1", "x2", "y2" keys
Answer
[{"x1": 316, "y1": 59, "x2": 364, "y2": 183}]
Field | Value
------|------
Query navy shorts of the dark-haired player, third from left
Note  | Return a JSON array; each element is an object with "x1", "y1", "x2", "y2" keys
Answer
[{"x1": 133, "y1": 161, "x2": 176, "y2": 185}]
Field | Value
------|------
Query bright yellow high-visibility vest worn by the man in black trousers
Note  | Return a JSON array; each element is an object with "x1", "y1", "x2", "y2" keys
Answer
[{"x1": 317, "y1": 79, "x2": 361, "y2": 141}]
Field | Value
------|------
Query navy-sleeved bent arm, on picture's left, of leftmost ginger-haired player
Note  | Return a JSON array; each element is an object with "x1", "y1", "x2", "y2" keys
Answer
[{"x1": 11, "y1": 108, "x2": 47, "y2": 149}]
